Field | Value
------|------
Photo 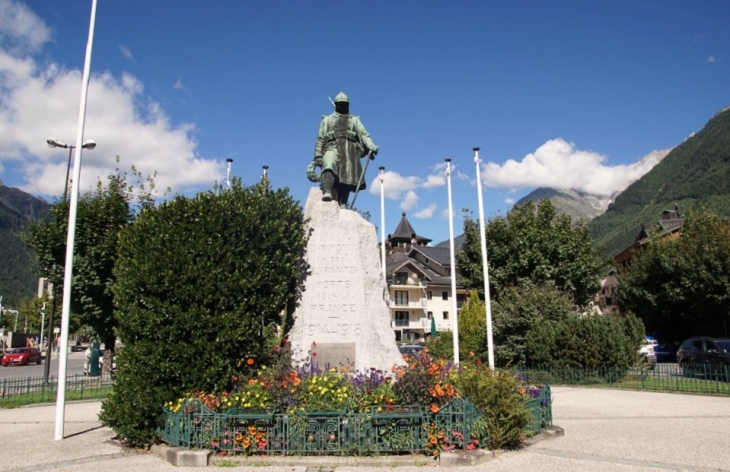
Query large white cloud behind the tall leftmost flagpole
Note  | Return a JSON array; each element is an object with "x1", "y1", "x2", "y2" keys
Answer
[{"x1": 0, "y1": 5, "x2": 225, "y2": 196}]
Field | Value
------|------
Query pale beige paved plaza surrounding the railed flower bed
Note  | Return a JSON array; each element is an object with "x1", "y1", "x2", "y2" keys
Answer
[{"x1": 0, "y1": 387, "x2": 730, "y2": 472}]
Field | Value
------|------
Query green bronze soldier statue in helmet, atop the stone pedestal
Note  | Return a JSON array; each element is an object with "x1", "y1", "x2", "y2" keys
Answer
[{"x1": 307, "y1": 92, "x2": 378, "y2": 207}]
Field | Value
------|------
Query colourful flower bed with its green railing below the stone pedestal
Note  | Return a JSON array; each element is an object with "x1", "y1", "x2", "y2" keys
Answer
[{"x1": 159, "y1": 353, "x2": 552, "y2": 457}]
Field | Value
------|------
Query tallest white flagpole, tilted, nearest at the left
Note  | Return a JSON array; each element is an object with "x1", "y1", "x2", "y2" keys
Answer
[{"x1": 54, "y1": 0, "x2": 97, "y2": 441}]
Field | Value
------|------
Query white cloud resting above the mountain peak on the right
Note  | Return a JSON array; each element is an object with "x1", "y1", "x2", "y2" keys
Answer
[{"x1": 482, "y1": 138, "x2": 670, "y2": 196}]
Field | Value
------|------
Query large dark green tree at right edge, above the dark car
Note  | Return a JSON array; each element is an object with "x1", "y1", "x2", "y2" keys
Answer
[{"x1": 616, "y1": 211, "x2": 730, "y2": 341}]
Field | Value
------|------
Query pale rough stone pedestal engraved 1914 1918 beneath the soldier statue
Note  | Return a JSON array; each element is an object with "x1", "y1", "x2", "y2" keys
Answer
[{"x1": 289, "y1": 188, "x2": 404, "y2": 371}]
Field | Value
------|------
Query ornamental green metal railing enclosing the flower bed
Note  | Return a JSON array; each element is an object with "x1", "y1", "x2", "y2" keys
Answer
[{"x1": 158, "y1": 386, "x2": 552, "y2": 455}]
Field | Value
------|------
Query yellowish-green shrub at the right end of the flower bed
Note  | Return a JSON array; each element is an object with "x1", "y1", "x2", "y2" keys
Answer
[{"x1": 454, "y1": 363, "x2": 531, "y2": 450}]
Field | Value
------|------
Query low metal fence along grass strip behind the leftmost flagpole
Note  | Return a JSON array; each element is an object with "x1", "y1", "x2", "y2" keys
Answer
[{"x1": 0, "y1": 373, "x2": 114, "y2": 408}]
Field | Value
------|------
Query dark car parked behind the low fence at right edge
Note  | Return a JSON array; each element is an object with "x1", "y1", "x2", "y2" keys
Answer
[{"x1": 677, "y1": 336, "x2": 730, "y2": 374}]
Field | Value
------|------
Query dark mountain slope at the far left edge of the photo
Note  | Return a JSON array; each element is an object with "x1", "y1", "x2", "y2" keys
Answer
[{"x1": 0, "y1": 182, "x2": 49, "y2": 307}]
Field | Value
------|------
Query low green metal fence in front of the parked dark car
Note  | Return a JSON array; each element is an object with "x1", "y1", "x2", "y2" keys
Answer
[{"x1": 514, "y1": 364, "x2": 730, "y2": 395}]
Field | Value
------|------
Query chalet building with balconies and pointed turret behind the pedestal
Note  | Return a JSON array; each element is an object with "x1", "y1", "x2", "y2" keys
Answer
[{"x1": 385, "y1": 213, "x2": 465, "y2": 342}]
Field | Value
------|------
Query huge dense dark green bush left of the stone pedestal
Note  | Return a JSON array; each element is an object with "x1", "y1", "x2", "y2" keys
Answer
[{"x1": 101, "y1": 180, "x2": 306, "y2": 445}]
